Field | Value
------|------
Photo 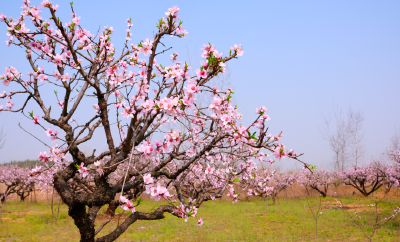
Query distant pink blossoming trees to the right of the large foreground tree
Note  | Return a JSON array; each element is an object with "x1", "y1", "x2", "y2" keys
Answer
[{"x1": 242, "y1": 146, "x2": 400, "y2": 202}]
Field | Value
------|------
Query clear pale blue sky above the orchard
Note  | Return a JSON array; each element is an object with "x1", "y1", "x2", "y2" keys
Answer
[{"x1": 0, "y1": 0, "x2": 400, "y2": 169}]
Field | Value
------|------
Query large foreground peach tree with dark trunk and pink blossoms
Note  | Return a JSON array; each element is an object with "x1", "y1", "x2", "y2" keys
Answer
[{"x1": 0, "y1": 0, "x2": 309, "y2": 241}]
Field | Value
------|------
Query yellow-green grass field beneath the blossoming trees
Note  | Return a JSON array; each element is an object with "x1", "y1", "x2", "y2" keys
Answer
[{"x1": 0, "y1": 196, "x2": 400, "y2": 242}]
